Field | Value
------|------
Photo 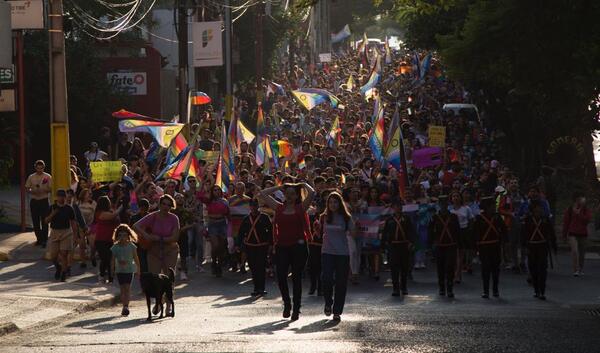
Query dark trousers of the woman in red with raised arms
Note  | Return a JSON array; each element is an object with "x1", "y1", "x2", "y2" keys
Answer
[{"x1": 275, "y1": 244, "x2": 308, "y2": 311}]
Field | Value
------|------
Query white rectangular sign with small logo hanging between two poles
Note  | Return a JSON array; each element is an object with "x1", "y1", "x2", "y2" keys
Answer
[{"x1": 192, "y1": 21, "x2": 223, "y2": 67}]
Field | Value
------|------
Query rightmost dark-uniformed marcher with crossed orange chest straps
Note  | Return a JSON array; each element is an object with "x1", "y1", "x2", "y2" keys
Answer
[{"x1": 521, "y1": 200, "x2": 556, "y2": 300}]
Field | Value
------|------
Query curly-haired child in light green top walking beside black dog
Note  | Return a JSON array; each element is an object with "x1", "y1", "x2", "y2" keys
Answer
[{"x1": 110, "y1": 224, "x2": 140, "y2": 316}]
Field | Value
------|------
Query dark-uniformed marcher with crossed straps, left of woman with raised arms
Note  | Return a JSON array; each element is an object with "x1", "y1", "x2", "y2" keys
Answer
[{"x1": 237, "y1": 199, "x2": 273, "y2": 297}]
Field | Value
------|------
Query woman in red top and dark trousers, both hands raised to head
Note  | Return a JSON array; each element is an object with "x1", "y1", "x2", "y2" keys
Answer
[{"x1": 259, "y1": 183, "x2": 315, "y2": 321}]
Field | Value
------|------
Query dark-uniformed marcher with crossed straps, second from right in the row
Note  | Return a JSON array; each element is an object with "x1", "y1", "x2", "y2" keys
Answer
[{"x1": 473, "y1": 196, "x2": 507, "y2": 299}]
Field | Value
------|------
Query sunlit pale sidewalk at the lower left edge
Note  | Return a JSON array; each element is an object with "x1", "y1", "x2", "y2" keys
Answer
[{"x1": 0, "y1": 233, "x2": 118, "y2": 337}]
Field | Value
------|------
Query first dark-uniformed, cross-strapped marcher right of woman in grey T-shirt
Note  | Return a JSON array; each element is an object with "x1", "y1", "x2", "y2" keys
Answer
[{"x1": 381, "y1": 199, "x2": 415, "y2": 297}]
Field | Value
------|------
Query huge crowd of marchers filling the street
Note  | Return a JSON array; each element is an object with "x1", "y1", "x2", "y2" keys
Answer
[{"x1": 26, "y1": 42, "x2": 591, "y2": 320}]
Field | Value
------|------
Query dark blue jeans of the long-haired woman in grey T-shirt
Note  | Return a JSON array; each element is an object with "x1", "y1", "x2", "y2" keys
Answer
[{"x1": 321, "y1": 254, "x2": 350, "y2": 315}]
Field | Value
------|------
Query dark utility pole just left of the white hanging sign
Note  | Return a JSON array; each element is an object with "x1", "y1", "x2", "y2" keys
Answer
[{"x1": 176, "y1": 0, "x2": 190, "y2": 123}]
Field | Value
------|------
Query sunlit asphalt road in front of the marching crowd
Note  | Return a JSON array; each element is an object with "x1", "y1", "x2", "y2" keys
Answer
[{"x1": 0, "y1": 258, "x2": 600, "y2": 353}]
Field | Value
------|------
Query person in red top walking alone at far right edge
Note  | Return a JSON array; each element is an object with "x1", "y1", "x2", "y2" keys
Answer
[{"x1": 563, "y1": 194, "x2": 592, "y2": 277}]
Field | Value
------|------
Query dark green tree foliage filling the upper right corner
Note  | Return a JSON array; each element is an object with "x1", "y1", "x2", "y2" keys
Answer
[{"x1": 386, "y1": 0, "x2": 600, "y2": 180}]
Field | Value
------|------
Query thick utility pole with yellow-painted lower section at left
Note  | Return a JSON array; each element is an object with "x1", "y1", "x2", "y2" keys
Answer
[{"x1": 48, "y1": 0, "x2": 71, "y2": 196}]
